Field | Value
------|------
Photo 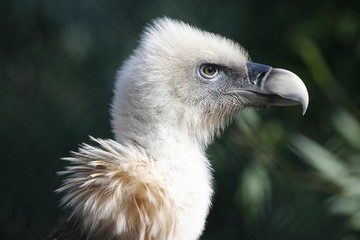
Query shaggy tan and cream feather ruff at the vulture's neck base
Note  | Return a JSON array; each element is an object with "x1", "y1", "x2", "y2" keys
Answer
[{"x1": 52, "y1": 138, "x2": 179, "y2": 239}]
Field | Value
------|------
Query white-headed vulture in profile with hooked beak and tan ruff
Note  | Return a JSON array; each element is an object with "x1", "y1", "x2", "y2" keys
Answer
[{"x1": 48, "y1": 17, "x2": 309, "y2": 240}]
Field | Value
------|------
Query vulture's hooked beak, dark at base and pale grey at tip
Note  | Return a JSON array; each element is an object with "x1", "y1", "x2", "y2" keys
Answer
[{"x1": 244, "y1": 62, "x2": 309, "y2": 114}]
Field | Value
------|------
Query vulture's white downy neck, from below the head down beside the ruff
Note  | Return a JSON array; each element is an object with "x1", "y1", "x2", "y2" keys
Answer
[{"x1": 113, "y1": 105, "x2": 213, "y2": 239}]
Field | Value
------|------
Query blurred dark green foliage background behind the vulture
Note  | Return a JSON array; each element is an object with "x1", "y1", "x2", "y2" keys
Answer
[{"x1": 0, "y1": 0, "x2": 360, "y2": 240}]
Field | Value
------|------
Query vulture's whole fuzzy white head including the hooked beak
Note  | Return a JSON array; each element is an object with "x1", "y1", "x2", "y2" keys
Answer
[{"x1": 113, "y1": 18, "x2": 308, "y2": 142}]
